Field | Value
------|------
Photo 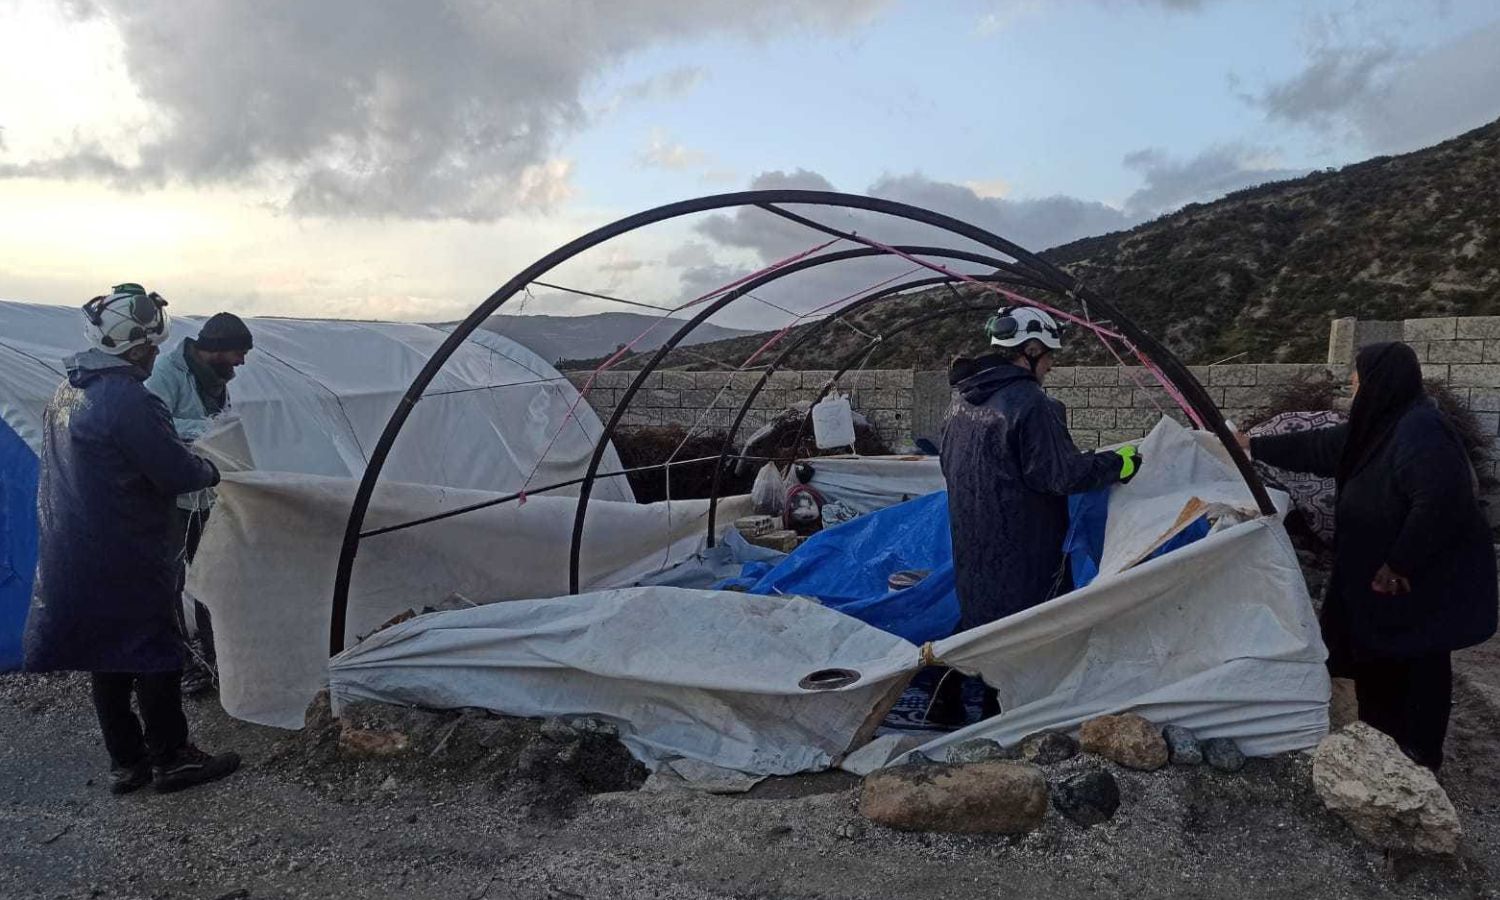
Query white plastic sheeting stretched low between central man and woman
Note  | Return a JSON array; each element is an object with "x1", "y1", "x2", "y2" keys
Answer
[{"x1": 921, "y1": 518, "x2": 1329, "y2": 756}]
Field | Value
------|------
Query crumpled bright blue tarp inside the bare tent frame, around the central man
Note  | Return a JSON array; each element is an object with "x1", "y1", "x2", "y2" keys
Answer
[{"x1": 732, "y1": 489, "x2": 1209, "y2": 644}]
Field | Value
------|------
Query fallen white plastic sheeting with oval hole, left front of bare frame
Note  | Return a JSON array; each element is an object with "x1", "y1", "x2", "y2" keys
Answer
[{"x1": 330, "y1": 588, "x2": 918, "y2": 774}]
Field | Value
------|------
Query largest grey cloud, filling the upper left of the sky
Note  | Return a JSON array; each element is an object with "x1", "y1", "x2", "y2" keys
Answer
[{"x1": 17, "y1": 0, "x2": 884, "y2": 221}]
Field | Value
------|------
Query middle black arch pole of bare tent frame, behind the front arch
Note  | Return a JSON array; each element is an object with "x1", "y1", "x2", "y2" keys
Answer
[{"x1": 569, "y1": 246, "x2": 1031, "y2": 594}]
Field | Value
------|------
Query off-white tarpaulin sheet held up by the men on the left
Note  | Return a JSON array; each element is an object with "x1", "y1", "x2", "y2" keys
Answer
[{"x1": 188, "y1": 473, "x2": 750, "y2": 728}]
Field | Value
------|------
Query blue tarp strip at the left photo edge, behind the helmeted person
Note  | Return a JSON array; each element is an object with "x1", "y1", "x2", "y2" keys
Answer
[{"x1": 0, "y1": 423, "x2": 38, "y2": 672}]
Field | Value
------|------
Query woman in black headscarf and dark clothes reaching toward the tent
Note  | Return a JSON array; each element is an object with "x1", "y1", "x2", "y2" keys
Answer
[{"x1": 1242, "y1": 344, "x2": 1497, "y2": 771}]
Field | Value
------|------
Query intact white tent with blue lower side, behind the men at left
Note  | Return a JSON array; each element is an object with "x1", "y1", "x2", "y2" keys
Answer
[{"x1": 0, "y1": 302, "x2": 635, "y2": 671}]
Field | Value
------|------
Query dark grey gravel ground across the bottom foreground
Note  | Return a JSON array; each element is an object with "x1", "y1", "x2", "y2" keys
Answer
[{"x1": 0, "y1": 654, "x2": 1500, "y2": 900}]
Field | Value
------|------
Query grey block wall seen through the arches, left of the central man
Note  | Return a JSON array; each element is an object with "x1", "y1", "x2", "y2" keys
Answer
[{"x1": 567, "y1": 369, "x2": 915, "y2": 450}]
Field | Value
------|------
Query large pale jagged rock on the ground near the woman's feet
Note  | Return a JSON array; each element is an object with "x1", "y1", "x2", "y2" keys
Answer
[{"x1": 1313, "y1": 722, "x2": 1463, "y2": 855}]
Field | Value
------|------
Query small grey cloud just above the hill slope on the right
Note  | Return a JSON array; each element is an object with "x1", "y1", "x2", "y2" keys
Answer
[{"x1": 1125, "y1": 144, "x2": 1307, "y2": 221}]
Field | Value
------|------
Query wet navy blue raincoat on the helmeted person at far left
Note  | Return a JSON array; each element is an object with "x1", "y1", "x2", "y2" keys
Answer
[{"x1": 24, "y1": 350, "x2": 219, "y2": 672}]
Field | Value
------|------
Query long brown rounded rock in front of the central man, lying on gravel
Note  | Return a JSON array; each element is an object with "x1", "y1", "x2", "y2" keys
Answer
[{"x1": 860, "y1": 761, "x2": 1047, "y2": 834}]
